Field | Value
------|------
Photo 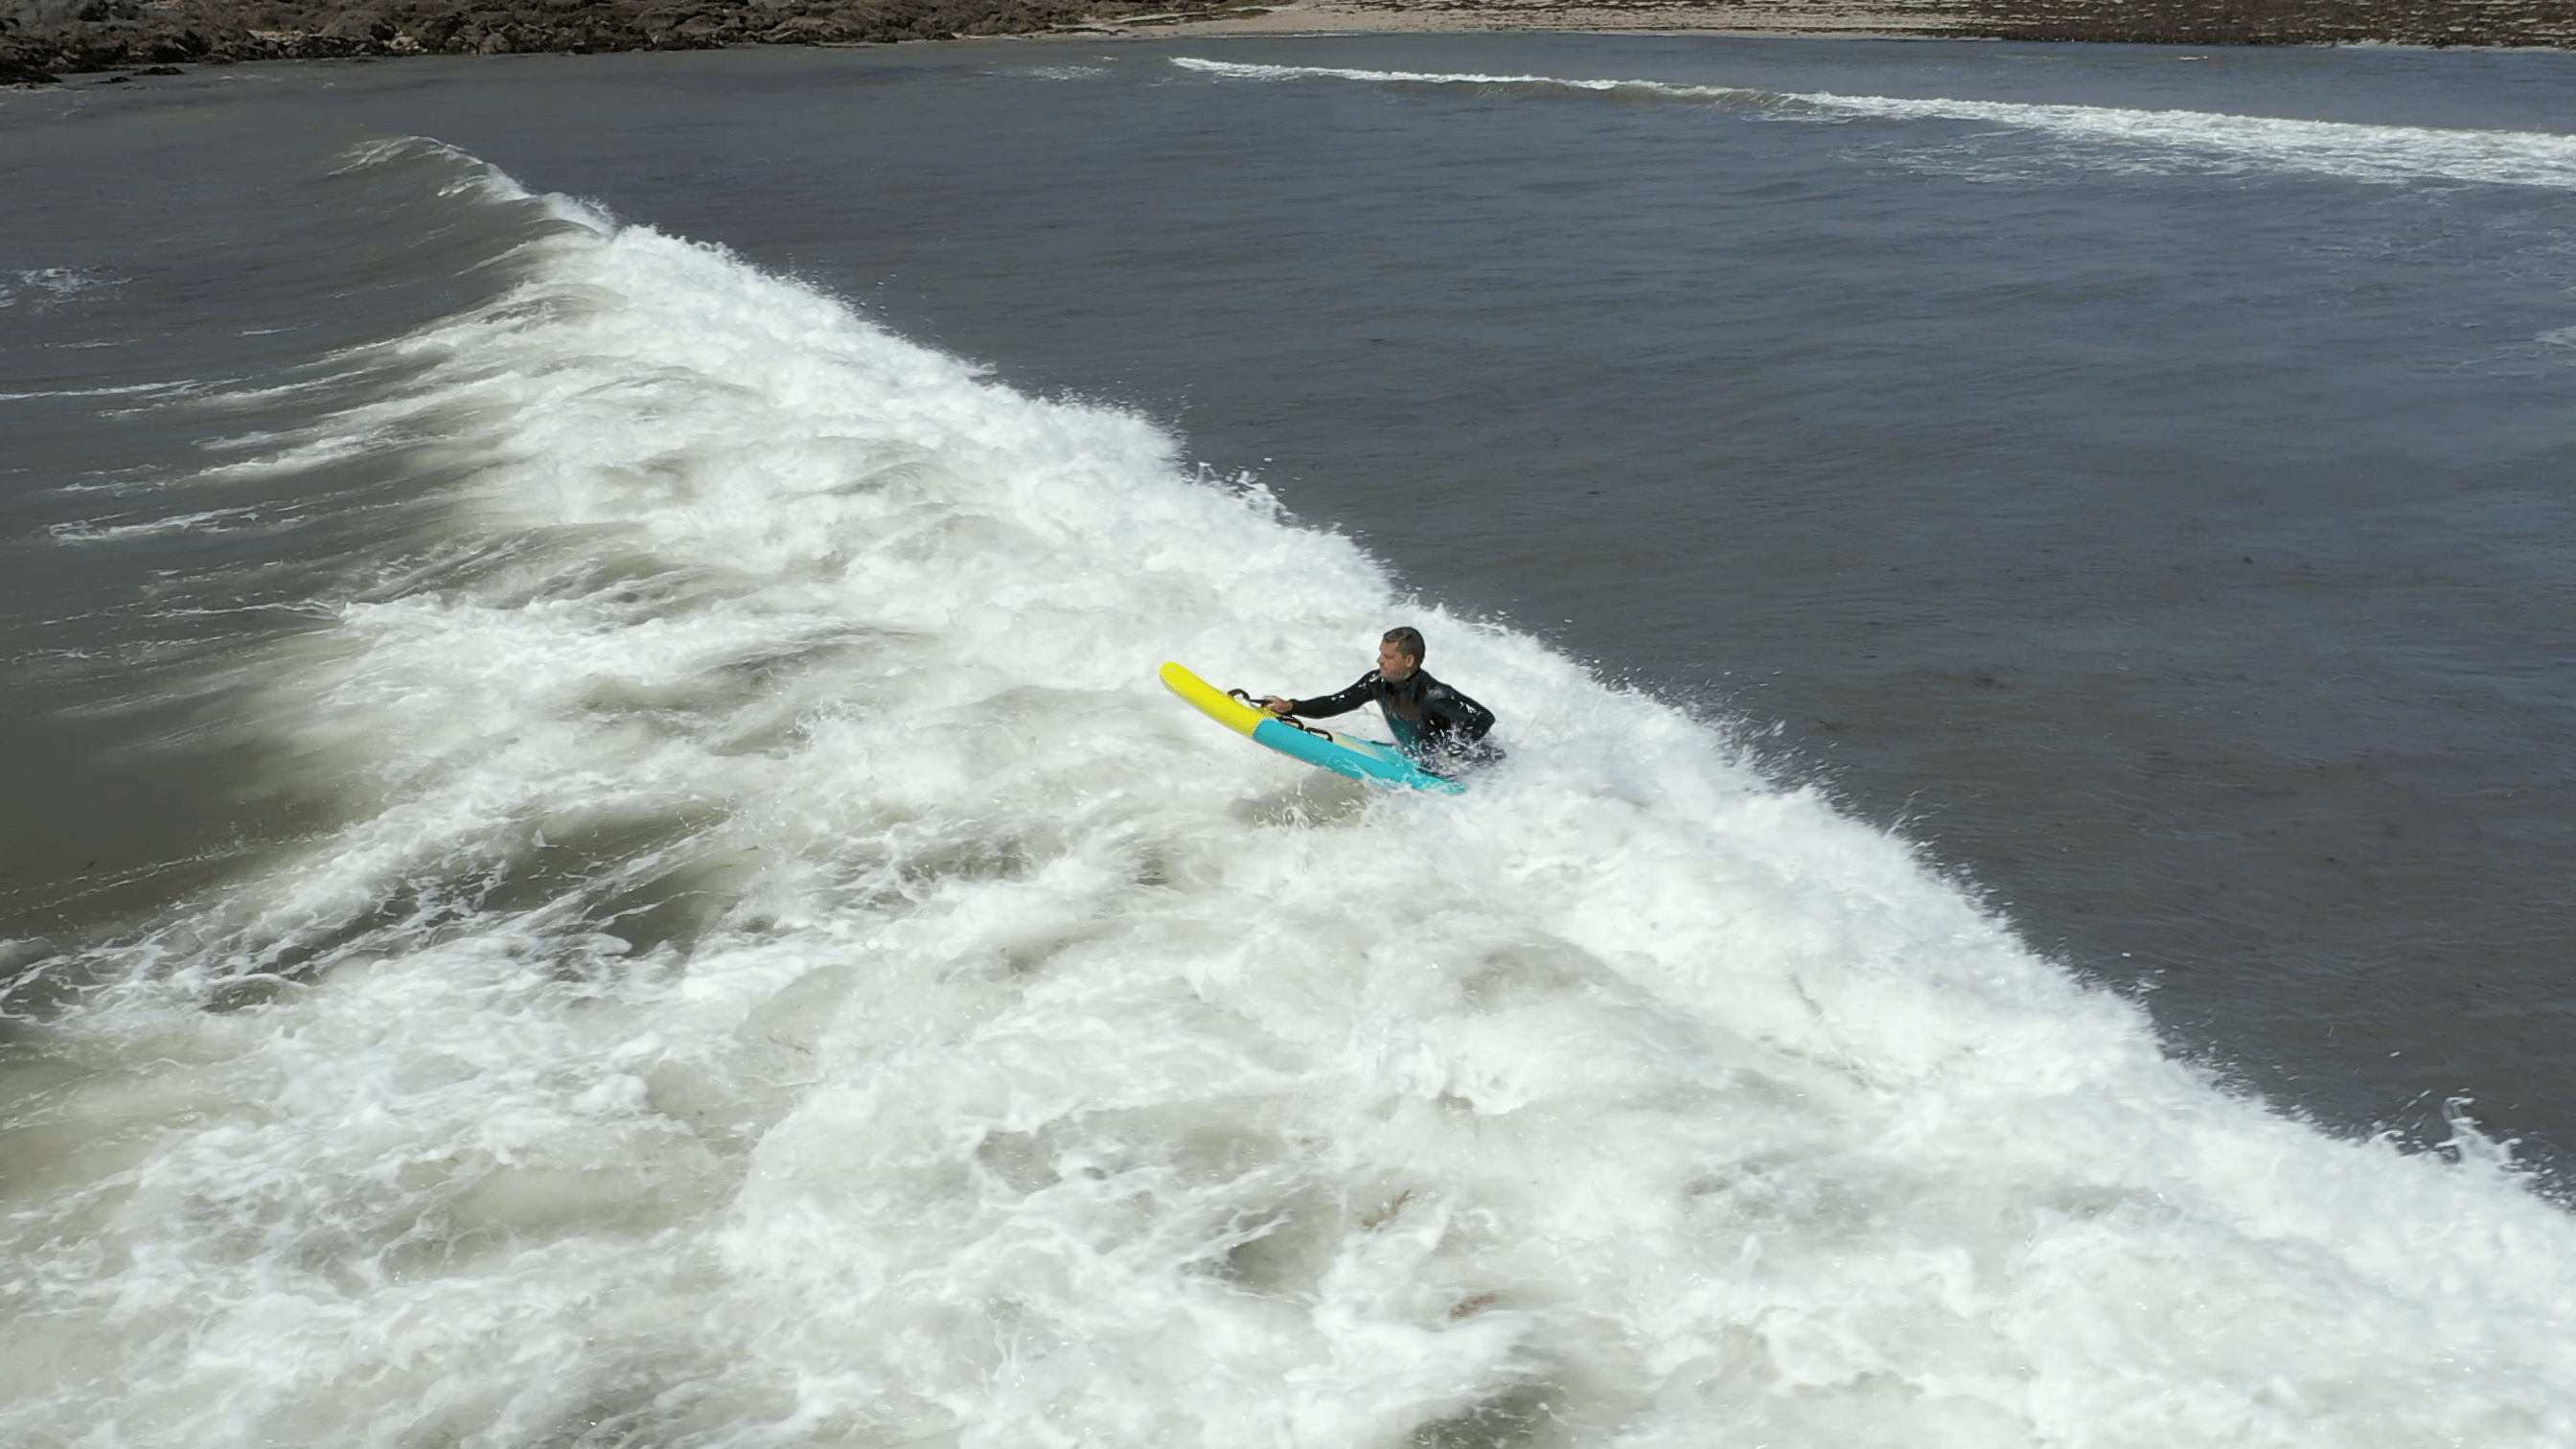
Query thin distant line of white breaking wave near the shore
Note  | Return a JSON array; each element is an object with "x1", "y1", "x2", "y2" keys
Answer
[{"x1": 1172, "y1": 57, "x2": 2576, "y2": 191}]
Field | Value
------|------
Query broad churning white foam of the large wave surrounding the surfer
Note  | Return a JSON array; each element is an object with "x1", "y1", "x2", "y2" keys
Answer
[{"x1": 0, "y1": 142, "x2": 2576, "y2": 1449}]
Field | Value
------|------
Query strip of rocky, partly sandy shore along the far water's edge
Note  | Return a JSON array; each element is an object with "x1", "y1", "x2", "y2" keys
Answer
[{"x1": 0, "y1": 0, "x2": 2576, "y2": 85}]
